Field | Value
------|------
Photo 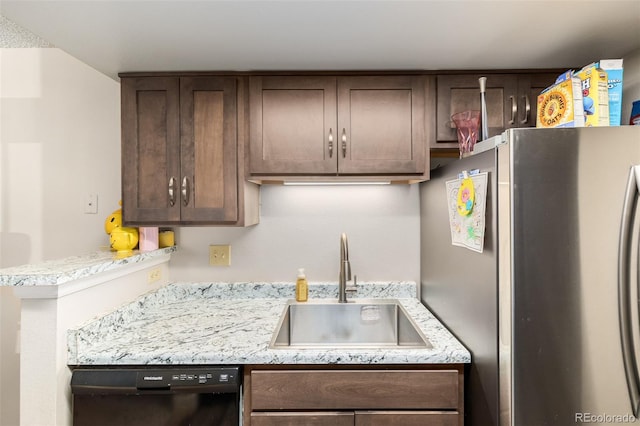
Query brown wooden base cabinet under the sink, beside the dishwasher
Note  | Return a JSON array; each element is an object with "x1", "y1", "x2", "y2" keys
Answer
[{"x1": 243, "y1": 364, "x2": 464, "y2": 426}]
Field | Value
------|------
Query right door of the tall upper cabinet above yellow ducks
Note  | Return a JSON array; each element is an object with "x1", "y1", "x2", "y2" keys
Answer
[{"x1": 178, "y1": 77, "x2": 238, "y2": 223}]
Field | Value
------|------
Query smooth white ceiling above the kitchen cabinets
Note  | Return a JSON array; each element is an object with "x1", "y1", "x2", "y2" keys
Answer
[{"x1": 0, "y1": 0, "x2": 640, "y2": 79}]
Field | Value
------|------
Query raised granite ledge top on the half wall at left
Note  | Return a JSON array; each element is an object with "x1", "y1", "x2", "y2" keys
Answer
[{"x1": 0, "y1": 246, "x2": 176, "y2": 286}]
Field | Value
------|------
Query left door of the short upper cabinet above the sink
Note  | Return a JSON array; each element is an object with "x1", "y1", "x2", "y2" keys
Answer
[{"x1": 249, "y1": 76, "x2": 338, "y2": 175}]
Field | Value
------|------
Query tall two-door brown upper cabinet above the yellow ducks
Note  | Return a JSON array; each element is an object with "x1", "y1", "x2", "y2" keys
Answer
[{"x1": 121, "y1": 76, "x2": 257, "y2": 225}]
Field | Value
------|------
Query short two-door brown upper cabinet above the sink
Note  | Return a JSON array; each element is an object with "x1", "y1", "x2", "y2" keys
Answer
[{"x1": 249, "y1": 75, "x2": 433, "y2": 179}]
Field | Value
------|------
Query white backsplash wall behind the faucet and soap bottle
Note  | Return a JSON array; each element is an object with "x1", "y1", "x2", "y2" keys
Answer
[{"x1": 170, "y1": 185, "x2": 420, "y2": 282}]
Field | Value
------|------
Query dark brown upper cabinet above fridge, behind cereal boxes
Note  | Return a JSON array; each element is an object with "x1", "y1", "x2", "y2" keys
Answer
[{"x1": 431, "y1": 73, "x2": 558, "y2": 148}]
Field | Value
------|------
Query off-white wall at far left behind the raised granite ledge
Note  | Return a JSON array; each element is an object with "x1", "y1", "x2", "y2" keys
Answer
[{"x1": 0, "y1": 48, "x2": 120, "y2": 426}]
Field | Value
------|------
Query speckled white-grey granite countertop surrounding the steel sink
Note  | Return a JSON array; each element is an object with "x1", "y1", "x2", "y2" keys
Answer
[{"x1": 68, "y1": 282, "x2": 471, "y2": 366}]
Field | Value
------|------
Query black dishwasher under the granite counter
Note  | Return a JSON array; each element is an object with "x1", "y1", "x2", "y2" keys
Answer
[{"x1": 71, "y1": 366, "x2": 240, "y2": 426}]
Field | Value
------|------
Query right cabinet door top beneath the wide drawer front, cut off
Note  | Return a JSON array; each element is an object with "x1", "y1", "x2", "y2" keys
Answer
[{"x1": 355, "y1": 411, "x2": 459, "y2": 426}]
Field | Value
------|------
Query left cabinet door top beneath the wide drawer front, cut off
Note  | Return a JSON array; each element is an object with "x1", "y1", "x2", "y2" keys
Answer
[{"x1": 251, "y1": 411, "x2": 354, "y2": 426}]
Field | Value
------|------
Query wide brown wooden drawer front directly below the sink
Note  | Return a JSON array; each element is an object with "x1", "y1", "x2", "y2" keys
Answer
[{"x1": 251, "y1": 370, "x2": 459, "y2": 410}]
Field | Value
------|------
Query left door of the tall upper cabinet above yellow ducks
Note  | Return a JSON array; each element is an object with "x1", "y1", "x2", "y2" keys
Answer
[{"x1": 121, "y1": 77, "x2": 180, "y2": 225}]
